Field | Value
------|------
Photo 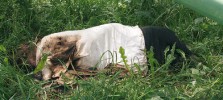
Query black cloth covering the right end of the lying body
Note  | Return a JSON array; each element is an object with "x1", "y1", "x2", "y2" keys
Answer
[{"x1": 141, "y1": 26, "x2": 192, "y2": 64}]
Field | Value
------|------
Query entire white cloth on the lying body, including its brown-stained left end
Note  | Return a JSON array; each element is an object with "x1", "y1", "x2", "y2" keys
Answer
[{"x1": 36, "y1": 23, "x2": 147, "y2": 79}]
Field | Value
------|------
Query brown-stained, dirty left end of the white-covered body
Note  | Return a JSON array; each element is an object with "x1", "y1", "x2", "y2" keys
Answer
[{"x1": 36, "y1": 33, "x2": 80, "y2": 80}]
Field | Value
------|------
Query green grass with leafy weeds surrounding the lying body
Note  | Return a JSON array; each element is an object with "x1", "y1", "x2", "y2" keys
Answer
[{"x1": 0, "y1": 0, "x2": 223, "y2": 100}]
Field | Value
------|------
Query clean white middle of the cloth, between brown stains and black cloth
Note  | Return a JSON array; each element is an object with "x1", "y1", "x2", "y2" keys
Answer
[{"x1": 74, "y1": 23, "x2": 147, "y2": 70}]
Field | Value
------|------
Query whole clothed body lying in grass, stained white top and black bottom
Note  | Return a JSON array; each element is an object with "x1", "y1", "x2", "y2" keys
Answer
[{"x1": 36, "y1": 23, "x2": 192, "y2": 80}]
